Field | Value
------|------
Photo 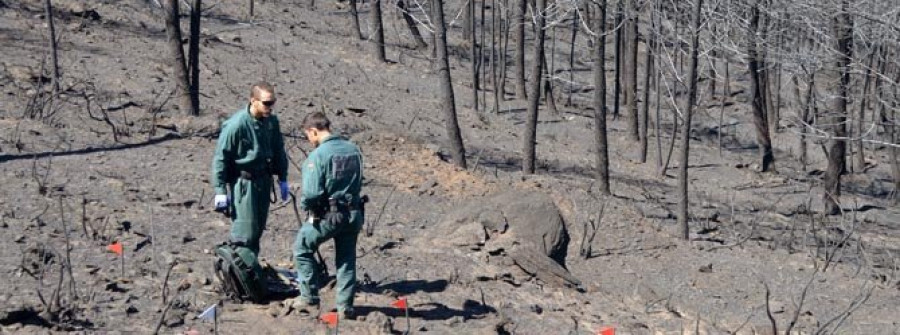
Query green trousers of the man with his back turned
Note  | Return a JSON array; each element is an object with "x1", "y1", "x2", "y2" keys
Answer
[{"x1": 294, "y1": 210, "x2": 365, "y2": 310}]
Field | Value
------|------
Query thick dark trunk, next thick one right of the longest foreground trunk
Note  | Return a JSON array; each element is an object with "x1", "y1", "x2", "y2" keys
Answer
[{"x1": 747, "y1": 0, "x2": 775, "y2": 172}]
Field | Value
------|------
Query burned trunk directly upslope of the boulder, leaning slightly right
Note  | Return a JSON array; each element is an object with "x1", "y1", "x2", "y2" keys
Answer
[{"x1": 522, "y1": 0, "x2": 545, "y2": 174}]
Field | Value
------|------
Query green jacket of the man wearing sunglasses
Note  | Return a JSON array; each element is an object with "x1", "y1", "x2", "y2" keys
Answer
[{"x1": 210, "y1": 105, "x2": 288, "y2": 194}]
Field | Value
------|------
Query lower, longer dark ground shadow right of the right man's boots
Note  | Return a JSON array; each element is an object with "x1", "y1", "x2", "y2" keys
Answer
[{"x1": 355, "y1": 300, "x2": 497, "y2": 325}]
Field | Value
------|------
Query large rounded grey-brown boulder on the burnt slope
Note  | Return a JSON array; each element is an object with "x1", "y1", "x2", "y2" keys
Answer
[{"x1": 432, "y1": 190, "x2": 580, "y2": 286}]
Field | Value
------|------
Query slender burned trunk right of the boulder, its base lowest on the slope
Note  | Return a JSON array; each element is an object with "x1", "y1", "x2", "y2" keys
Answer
[{"x1": 678, "y1": 0, "x2": 703, "y2": 240}]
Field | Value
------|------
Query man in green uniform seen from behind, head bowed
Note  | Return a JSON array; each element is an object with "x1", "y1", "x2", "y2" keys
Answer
[{"x1": 294, "y1": 112, "x2": 365, "y2": 318}]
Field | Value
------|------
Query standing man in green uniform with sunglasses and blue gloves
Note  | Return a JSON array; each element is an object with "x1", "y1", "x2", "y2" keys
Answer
[{"x1": 211, "y1": 82, "x2": 288, "y2": 256}]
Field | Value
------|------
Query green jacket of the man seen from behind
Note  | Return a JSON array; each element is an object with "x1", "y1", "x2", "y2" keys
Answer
[{"x1": 300, "y1": 135, "x2": 363, "y2": 211}]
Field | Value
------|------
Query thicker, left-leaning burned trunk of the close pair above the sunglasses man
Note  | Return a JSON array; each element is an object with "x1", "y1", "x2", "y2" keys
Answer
[{"x1": 166, "y1": 0, "x2": 199, "y2": 115}]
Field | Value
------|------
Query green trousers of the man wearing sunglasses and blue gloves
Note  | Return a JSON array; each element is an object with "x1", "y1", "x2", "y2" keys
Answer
[{"x1": 231, "y1": 177, "x2": 272, "y2": 255}]
